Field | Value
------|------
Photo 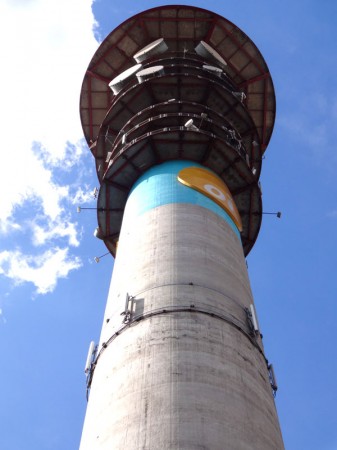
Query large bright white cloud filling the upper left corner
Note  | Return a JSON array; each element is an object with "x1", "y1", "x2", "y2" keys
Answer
[{"x1": 0, "y1": 0, "x2": 97, "y2": 228}]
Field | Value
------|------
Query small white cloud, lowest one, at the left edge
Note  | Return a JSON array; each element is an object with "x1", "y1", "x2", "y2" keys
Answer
[{"x1": 0, "y1": 247, "x2": 81, "y2": 294}]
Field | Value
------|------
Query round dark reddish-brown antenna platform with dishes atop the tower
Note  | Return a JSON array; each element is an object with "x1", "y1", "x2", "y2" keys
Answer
[{"x1": 80, "y1": 5, "x2": 275, "y2": 255}]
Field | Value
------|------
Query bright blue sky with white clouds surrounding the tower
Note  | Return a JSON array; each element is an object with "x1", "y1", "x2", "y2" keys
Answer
[{"x1": 0, "y1": 0, "x2": 337, "y2": 450}]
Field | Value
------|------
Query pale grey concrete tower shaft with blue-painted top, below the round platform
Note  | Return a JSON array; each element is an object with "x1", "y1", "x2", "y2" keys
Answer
[{"x1": 81, "y1": 162, "x2": 283, "y2": 450}]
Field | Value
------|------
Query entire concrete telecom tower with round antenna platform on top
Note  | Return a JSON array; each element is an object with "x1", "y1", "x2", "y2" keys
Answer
[{"x1": 80, "y1": 5, "x2": 283, "y2": 450}]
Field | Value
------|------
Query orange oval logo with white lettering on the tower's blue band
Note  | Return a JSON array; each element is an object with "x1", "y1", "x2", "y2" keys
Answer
[{"x1": 178, "y1": 167, "x2": 242, "y2": 231}]
